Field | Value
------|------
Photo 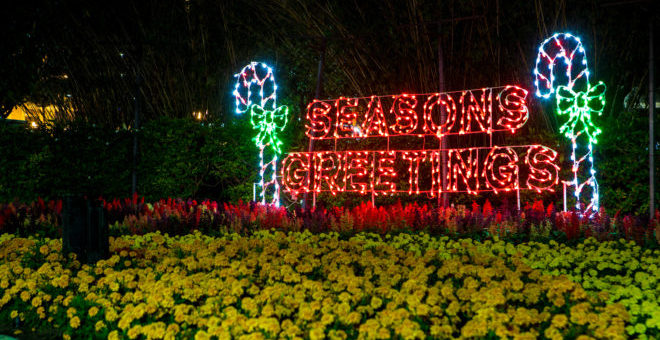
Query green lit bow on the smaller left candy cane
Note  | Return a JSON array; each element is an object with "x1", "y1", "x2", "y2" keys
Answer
[{"x1": 250, "y1": 104, "x2": 289, "y2": 154}]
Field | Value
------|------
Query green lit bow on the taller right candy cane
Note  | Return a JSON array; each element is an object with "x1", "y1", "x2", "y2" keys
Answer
[{"x1": 557, "y1": 81, "x2": 606, "y2": 144}]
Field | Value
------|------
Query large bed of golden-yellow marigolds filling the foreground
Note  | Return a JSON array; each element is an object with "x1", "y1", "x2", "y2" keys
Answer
[{"x1": 0, "y1": 231, "x2": 640, "y2": 339}]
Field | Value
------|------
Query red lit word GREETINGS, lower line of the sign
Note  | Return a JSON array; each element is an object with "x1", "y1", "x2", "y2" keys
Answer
[{"x1": 281, "y1": 145, "x2": 559, "y2": 197}]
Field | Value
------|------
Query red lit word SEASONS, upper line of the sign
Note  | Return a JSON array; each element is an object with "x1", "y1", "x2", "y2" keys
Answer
[{"x1": 305, "y1": 85, "x2": 529, "y2": 140}]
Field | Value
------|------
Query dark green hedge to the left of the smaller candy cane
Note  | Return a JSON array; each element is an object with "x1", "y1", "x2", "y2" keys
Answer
[{"x1": 0, "y1": 118, "x2": 257, "y2": 202}]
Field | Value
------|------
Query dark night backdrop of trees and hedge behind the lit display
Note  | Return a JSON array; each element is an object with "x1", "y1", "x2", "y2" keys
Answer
[{"x1": 0, "y1": 0, "x2": 658, "y2": 212}]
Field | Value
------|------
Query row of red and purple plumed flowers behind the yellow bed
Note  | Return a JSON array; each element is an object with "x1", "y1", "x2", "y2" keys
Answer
[{"x1": 0, "y1": 195, "x2": 660, "y2": 247}]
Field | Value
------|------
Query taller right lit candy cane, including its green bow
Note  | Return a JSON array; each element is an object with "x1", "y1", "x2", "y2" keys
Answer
[{"x1": 534, "y1": 33, "x2": 606, "y2": 212}]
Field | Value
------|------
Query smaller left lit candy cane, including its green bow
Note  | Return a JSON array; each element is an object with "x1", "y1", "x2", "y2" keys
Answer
[{"x1": 233, "y1": 62, "x2": 289, "y2": 206}]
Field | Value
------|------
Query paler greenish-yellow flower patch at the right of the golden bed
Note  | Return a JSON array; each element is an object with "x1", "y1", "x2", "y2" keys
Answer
[{"x1": 376, "y1": 234, "x2": 660, "y2": 339}]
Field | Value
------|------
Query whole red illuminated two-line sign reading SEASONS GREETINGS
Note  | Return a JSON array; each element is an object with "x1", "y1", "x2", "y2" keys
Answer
[{"x1": 280, "y1": 86, "x2": 559, "y2": 197}]
